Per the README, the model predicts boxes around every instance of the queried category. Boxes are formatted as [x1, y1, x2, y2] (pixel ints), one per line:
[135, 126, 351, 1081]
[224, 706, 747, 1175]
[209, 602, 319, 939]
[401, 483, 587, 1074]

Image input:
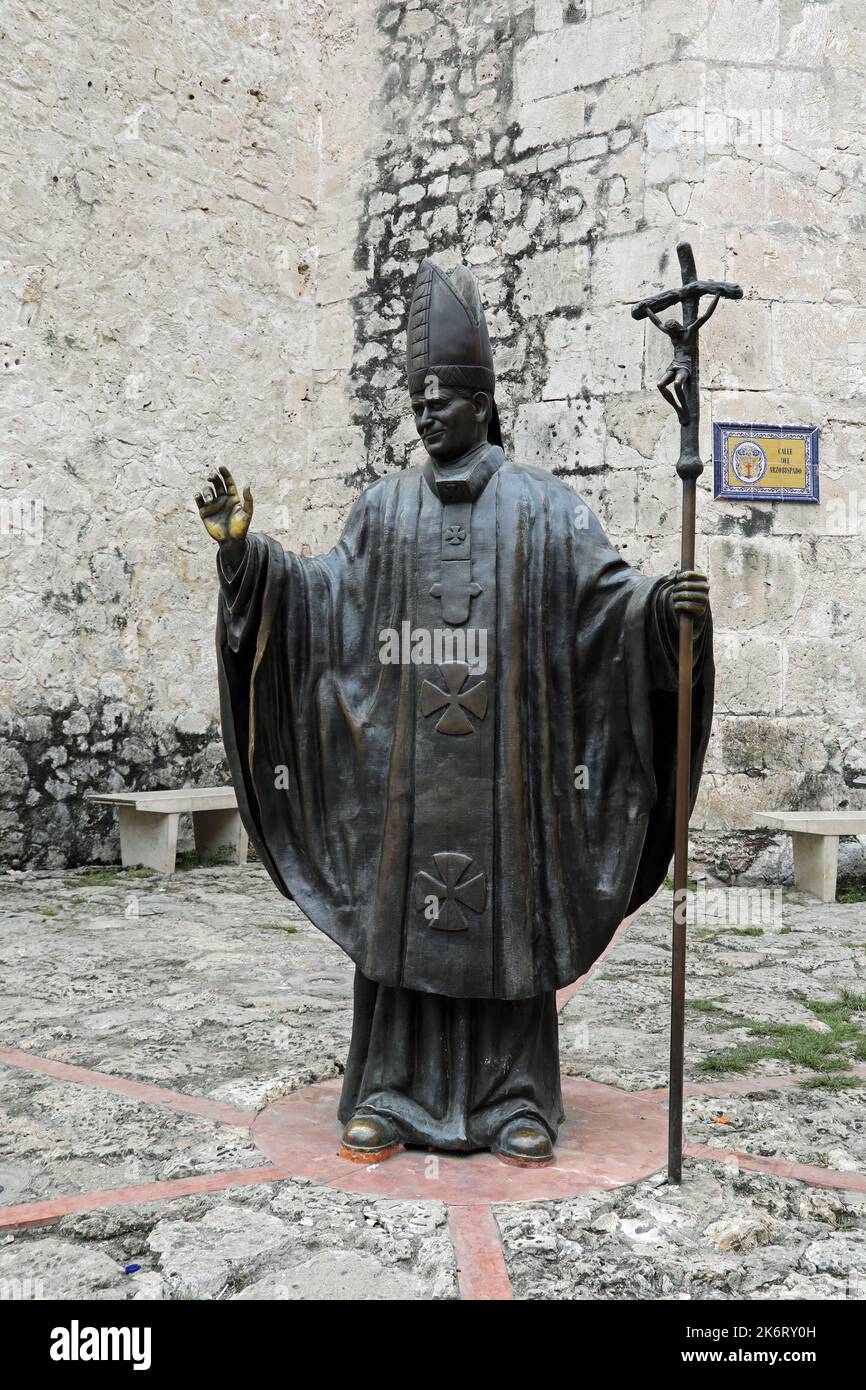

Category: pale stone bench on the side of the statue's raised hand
[85, 787, 249, 873]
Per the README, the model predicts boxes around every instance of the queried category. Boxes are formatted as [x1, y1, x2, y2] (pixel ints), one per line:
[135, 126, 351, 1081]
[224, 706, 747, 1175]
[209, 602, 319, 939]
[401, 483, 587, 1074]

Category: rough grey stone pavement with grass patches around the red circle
[0, 866, 866, 1300]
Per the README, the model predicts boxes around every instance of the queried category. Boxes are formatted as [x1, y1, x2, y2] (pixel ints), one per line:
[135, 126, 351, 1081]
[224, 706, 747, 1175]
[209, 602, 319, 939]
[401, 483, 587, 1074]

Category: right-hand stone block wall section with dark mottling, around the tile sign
[333, 0, 866, 872]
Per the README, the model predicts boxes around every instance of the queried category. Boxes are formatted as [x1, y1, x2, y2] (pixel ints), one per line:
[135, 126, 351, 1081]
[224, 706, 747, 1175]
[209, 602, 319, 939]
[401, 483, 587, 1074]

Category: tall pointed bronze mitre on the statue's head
[406, 259, 496, 396]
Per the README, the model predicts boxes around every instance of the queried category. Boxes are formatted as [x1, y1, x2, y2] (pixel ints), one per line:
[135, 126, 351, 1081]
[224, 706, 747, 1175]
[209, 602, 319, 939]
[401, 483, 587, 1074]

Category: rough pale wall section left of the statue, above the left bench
[0, 0, 378, 863]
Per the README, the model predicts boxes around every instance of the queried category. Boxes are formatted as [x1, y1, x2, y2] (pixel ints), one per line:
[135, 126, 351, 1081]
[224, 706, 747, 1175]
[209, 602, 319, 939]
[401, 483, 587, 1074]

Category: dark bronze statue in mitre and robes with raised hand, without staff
[196, 260, 713, 1165]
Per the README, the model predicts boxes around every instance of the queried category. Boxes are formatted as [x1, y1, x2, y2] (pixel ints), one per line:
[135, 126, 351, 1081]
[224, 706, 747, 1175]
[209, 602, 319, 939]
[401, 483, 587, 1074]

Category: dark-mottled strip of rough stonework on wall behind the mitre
[352, 4, 584, 488]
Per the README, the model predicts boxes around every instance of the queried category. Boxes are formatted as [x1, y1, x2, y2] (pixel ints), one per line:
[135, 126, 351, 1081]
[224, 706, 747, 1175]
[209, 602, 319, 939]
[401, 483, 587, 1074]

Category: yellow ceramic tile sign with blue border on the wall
[713, 421, 819, 502]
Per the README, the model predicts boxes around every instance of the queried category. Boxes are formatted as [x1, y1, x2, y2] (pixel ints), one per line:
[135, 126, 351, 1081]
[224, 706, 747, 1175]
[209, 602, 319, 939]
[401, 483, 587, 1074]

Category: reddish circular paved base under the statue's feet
[253, 1076, 667, 1205]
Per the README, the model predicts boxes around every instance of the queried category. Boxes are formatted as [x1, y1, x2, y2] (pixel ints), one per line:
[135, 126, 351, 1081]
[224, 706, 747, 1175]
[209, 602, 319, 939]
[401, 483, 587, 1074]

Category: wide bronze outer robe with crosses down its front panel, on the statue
[217, 443, 713, 999]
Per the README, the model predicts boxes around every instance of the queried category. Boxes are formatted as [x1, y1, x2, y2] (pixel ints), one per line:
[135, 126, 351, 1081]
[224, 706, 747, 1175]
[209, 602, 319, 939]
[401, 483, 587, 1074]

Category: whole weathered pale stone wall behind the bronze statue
[0, 0, 866, 872]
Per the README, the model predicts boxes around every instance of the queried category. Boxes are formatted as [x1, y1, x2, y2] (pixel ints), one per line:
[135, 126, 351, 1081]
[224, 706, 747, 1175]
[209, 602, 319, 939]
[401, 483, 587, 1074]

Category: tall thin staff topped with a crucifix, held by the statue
[631, 242, 742, 1183]
